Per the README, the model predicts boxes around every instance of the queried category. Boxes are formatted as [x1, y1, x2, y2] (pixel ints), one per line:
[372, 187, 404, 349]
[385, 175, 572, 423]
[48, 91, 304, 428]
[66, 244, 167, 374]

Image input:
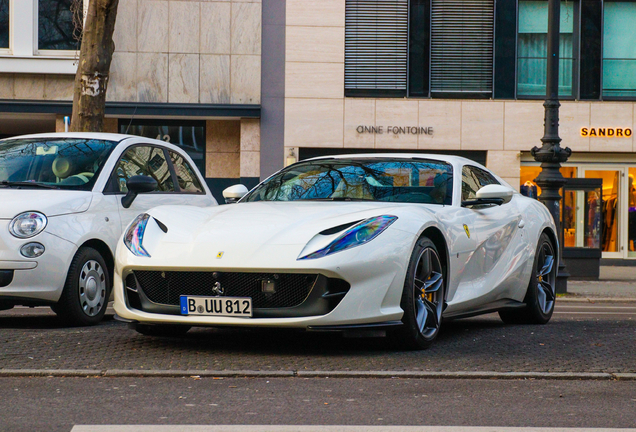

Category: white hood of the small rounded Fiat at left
[0, 188, 93, 219]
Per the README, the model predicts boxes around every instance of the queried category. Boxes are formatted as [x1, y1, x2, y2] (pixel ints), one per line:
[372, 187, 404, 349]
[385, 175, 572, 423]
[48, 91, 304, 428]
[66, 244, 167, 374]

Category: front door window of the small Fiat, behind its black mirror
[114, 146, 175, 192]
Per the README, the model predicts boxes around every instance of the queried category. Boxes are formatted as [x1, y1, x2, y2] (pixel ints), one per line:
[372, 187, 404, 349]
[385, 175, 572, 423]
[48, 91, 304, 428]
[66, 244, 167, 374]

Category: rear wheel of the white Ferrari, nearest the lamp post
[499, 233, 558, 324]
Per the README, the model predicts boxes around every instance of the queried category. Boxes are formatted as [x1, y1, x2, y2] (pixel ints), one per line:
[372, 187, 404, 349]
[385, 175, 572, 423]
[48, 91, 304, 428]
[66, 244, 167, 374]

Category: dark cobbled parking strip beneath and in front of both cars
[0, 302, 636, 373]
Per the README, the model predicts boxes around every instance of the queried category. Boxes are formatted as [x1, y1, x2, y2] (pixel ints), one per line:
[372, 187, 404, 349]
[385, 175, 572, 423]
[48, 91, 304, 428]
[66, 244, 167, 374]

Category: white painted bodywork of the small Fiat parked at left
[0, 133, 217, 305]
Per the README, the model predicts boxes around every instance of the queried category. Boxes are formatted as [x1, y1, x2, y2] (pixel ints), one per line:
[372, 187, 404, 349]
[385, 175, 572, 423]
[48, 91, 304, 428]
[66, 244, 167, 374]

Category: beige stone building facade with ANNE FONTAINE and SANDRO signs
[272, 0, 636, 260]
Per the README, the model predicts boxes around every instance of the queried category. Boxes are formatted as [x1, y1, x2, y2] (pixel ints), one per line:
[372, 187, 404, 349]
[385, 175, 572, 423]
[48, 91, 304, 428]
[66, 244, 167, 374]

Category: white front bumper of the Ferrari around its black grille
[114, 226, 412, 329]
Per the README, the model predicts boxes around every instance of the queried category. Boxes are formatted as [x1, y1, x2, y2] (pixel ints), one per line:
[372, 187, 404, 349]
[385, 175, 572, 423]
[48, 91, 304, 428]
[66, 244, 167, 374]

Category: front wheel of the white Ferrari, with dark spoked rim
[396, 237, 446, 350]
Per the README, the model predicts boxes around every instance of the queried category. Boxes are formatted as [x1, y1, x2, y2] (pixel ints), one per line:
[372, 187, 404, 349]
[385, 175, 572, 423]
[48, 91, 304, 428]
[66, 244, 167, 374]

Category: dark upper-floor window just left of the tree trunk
[38, 0, 83, 51]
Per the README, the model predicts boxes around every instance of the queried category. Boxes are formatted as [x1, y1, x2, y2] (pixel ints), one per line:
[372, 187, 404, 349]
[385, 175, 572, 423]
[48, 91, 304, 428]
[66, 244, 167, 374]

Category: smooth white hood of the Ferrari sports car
[145, 201, 422, 249]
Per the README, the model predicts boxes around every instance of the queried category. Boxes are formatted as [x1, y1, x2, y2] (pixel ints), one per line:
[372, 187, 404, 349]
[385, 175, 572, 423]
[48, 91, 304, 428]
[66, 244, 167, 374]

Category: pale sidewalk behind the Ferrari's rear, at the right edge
[565, 266, 636, 301]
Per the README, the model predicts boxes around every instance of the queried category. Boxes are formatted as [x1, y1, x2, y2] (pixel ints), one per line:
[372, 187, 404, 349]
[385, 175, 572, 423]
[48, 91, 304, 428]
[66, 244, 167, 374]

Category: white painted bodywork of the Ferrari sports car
[114, 154, 558, 340]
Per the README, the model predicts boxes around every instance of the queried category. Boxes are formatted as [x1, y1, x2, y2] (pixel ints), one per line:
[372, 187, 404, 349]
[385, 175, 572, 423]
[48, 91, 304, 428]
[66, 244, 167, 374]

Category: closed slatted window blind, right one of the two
[431, 0, 495, 93]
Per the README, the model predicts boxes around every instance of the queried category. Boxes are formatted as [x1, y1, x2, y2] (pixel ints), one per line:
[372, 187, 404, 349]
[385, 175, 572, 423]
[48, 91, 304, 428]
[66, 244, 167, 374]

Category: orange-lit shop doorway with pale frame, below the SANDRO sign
[584, 166, 626, 258]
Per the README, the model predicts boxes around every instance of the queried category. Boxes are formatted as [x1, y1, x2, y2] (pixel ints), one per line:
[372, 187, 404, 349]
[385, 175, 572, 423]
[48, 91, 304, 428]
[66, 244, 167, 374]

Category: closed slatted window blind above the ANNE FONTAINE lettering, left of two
[345, 0, 409, 91]
